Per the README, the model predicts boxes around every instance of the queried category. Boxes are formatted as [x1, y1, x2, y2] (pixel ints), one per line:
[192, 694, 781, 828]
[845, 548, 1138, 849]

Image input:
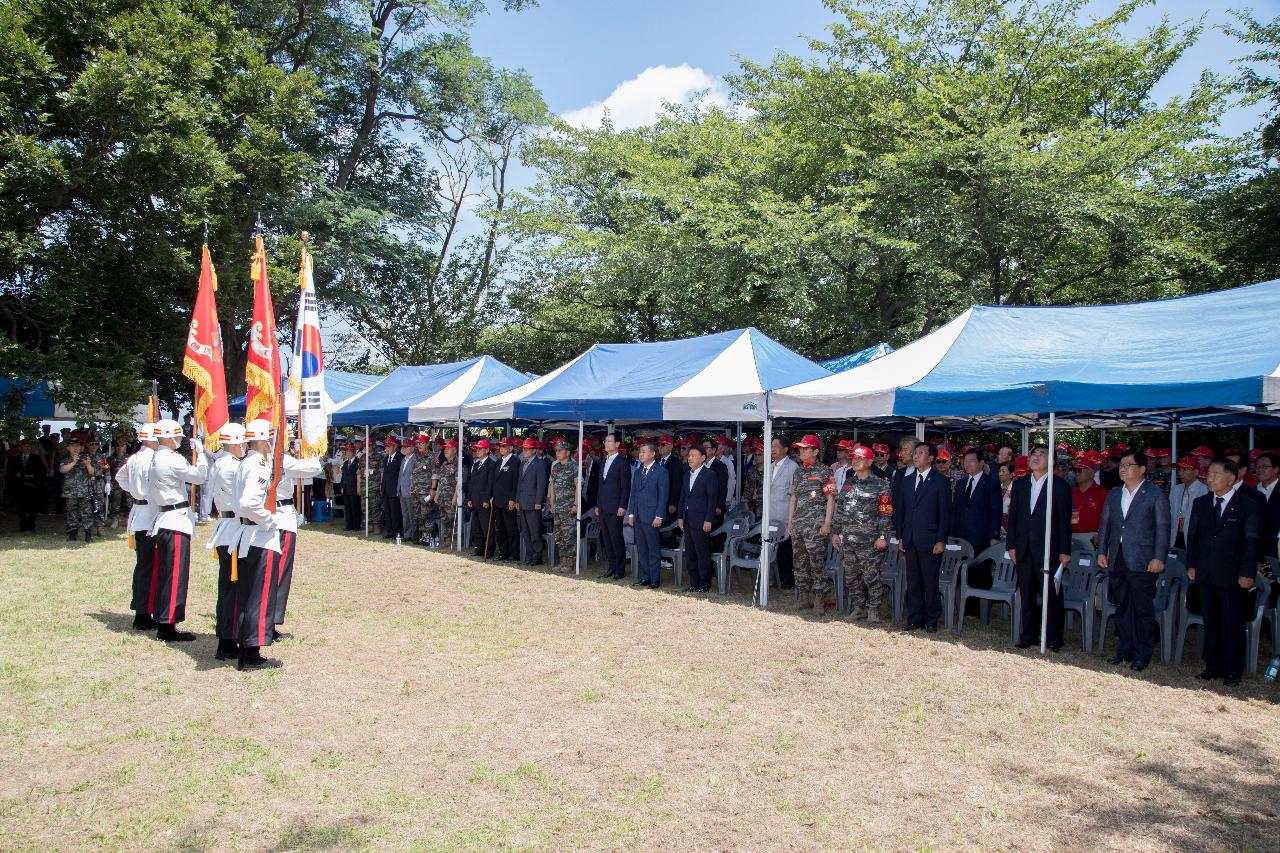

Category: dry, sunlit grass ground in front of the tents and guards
[0, 519, 1280, 850]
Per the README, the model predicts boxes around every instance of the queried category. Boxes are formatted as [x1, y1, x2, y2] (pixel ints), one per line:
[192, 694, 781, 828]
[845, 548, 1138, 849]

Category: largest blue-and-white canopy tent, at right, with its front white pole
[762, 280, 1280, 640]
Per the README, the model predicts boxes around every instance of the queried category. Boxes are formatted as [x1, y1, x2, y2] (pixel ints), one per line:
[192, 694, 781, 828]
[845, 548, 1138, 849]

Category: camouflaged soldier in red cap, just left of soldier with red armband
[787, 435, 836, 616]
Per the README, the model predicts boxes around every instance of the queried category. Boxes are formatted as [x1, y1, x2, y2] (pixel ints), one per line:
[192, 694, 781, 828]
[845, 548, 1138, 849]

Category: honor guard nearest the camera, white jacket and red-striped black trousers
[233, 418, 283, 670]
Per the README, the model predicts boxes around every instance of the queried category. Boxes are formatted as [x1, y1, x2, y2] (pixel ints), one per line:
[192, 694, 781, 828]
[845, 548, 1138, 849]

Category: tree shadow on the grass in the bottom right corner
[1028, 738, 1280, 850]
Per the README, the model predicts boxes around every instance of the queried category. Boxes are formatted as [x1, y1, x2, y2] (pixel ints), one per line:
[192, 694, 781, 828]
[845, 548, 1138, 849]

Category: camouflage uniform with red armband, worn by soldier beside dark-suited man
[831, 471, 893, 619]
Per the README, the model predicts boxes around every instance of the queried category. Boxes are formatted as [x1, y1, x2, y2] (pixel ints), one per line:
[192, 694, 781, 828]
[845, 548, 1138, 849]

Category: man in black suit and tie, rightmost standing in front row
[1187, 459, 1262, 686]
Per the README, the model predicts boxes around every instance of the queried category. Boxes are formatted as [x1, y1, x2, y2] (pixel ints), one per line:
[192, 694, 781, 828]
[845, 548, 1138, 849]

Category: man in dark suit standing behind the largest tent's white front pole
[997, 444, 1070, 652]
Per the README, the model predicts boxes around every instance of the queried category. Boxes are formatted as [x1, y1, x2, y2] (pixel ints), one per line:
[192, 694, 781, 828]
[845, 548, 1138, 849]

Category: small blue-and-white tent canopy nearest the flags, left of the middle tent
[330, 356, 529, 427]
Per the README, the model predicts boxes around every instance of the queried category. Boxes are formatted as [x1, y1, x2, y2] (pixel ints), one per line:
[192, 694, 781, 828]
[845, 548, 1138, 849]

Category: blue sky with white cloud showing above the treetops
[472, 0, 1280, 134]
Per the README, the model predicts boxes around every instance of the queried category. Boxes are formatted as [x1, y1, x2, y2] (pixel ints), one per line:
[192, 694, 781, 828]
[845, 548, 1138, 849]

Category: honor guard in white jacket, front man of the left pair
[147, 419, 209, 643]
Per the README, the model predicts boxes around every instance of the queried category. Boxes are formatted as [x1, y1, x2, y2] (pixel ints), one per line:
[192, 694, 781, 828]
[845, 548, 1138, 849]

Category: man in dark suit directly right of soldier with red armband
[893, 439, 951, 634]
